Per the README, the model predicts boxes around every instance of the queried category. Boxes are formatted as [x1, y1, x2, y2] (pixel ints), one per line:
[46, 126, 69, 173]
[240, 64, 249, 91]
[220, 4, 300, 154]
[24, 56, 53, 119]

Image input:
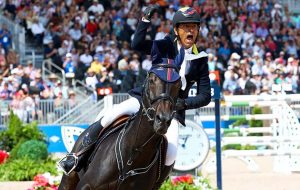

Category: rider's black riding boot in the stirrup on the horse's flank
[58, 119, 103, 175]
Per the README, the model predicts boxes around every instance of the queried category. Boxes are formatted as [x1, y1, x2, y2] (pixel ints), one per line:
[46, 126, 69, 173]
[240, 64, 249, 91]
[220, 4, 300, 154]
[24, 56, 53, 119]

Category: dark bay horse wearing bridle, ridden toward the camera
[59, 64, 181, 190]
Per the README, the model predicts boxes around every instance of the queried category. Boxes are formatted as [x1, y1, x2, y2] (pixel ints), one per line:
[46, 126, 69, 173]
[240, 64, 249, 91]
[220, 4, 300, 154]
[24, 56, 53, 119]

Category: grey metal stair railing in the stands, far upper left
[0, 13, 26, 63]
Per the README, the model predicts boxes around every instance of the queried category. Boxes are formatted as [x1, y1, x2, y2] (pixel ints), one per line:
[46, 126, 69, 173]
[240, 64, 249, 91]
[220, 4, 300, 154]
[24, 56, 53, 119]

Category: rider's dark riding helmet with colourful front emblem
[173, 7, 200, 28]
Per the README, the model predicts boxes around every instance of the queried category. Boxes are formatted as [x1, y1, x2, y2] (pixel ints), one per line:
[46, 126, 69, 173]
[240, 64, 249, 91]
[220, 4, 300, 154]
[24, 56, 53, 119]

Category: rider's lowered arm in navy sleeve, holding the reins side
[185, 58, 211, 109]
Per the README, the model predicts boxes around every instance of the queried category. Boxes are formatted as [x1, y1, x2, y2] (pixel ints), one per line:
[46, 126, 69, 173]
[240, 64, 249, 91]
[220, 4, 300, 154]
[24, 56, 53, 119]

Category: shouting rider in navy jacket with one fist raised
[59, 5, 211, 182]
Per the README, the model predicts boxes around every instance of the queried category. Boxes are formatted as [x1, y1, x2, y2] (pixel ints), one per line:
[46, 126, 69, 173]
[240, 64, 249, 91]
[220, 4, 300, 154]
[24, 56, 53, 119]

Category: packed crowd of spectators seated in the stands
[0, 0, 300, 120]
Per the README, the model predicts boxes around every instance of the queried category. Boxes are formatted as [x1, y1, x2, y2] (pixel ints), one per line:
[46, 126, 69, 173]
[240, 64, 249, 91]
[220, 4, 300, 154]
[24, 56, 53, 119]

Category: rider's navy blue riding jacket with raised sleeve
[129, 21, 211, 125]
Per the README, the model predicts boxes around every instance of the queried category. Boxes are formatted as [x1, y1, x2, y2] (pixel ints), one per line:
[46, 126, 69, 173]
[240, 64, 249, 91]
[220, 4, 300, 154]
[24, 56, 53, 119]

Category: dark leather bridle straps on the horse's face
[142, 64, 179, 121]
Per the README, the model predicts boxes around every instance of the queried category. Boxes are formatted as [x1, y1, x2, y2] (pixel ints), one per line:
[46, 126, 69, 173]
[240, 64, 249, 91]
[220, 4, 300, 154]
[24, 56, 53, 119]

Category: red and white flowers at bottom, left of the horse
[28, 173, 61, 190]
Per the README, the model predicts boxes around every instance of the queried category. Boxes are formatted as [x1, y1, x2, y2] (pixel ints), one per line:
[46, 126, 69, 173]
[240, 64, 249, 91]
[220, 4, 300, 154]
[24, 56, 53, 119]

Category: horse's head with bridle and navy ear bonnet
[143, 64, 181, 135]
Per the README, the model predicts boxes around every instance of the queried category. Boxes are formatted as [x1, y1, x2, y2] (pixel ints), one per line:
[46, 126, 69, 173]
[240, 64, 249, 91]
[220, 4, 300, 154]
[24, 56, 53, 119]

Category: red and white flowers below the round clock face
[160, 174, 213, 190]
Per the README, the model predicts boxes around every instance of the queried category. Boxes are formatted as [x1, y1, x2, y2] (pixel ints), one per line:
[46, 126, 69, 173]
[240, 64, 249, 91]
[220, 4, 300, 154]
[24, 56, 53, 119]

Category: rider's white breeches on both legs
[101, 98, 179, 166]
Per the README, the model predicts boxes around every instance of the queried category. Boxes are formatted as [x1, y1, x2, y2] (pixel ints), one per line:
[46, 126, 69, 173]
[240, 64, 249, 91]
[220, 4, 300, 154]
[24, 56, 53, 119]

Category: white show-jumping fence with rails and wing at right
[207, 101, 300, 173]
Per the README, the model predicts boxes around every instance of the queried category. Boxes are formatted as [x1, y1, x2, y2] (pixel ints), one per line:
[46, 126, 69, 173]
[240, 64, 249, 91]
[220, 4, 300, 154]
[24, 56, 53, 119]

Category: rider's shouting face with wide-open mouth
[174, 23, 199, 49]
